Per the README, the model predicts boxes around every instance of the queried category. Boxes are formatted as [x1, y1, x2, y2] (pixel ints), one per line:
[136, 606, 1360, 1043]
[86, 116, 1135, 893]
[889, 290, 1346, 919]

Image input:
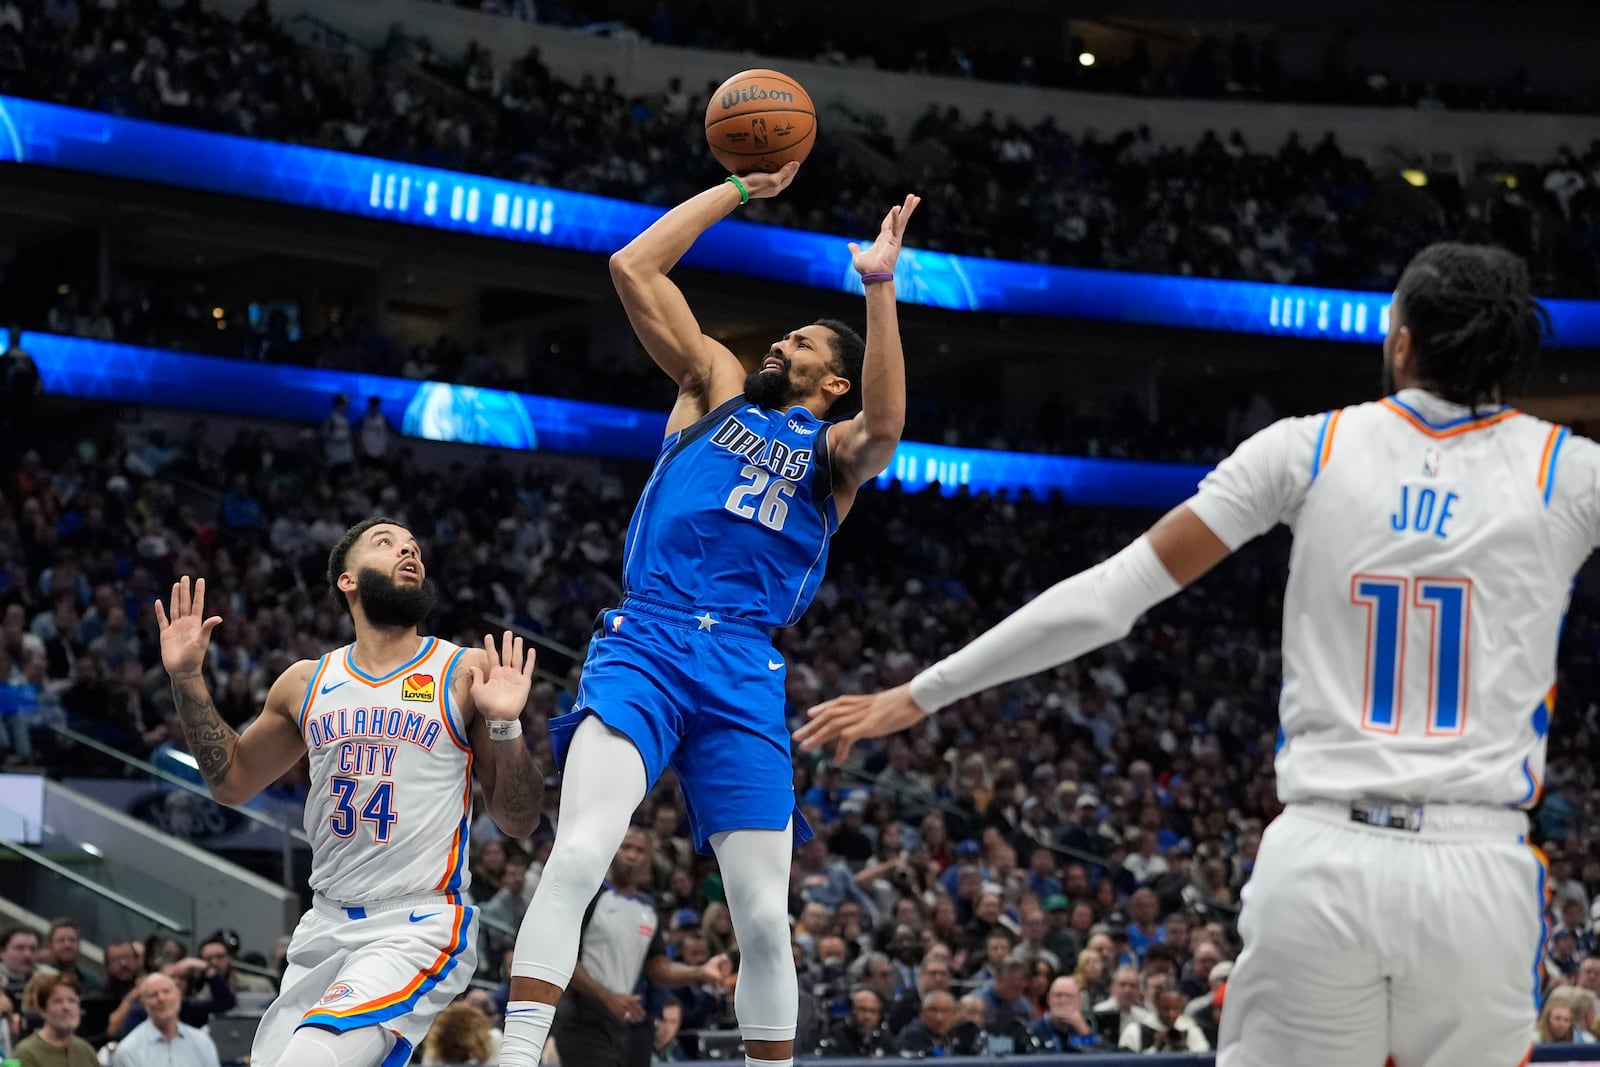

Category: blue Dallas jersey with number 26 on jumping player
[622, 395, 838, 627]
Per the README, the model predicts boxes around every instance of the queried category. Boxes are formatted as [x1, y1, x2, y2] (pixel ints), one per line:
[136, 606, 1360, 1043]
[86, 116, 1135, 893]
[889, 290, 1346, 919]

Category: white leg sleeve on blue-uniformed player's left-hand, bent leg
[510, 715, 645, 989]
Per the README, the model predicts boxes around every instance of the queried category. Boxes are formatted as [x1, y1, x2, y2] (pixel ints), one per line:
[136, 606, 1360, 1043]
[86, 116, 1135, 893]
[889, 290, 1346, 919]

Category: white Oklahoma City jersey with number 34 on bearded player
[299, 637, 472, 905]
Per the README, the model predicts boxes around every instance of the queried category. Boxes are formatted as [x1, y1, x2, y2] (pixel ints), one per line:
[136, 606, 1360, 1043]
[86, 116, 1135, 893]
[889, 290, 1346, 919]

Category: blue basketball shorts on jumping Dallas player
[550, 597, 811, 853]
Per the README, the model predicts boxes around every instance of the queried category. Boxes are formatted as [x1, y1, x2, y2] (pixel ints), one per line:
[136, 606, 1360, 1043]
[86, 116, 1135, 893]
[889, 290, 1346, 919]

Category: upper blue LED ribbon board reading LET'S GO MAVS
[9, 96, 1600, 347]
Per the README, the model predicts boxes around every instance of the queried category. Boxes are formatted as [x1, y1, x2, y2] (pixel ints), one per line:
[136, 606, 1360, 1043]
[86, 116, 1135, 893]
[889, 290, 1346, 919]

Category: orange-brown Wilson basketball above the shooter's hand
[706, 70, 816, 174]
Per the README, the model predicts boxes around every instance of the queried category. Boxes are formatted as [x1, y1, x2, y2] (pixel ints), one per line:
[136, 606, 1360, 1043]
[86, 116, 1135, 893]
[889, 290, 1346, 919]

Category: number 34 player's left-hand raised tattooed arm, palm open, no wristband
[155, 574, 315, 805]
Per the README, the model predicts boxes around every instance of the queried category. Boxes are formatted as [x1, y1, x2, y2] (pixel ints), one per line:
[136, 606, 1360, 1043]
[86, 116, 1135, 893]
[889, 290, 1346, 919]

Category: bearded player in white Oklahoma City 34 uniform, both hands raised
[155, 518, 544, 1067]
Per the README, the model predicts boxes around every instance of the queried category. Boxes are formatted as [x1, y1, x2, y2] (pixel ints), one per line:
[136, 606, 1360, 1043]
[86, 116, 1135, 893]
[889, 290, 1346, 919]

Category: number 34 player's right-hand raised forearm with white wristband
[450, 630, 544, 840]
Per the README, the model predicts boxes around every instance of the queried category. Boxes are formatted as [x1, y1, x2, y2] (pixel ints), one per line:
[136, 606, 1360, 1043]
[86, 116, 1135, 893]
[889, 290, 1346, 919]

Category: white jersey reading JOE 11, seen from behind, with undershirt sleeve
[1190, 389, 1600, 806]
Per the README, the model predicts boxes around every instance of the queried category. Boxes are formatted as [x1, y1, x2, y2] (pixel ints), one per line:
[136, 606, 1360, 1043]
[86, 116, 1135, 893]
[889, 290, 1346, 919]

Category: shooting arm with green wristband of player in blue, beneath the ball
[611, 163, 800, 434]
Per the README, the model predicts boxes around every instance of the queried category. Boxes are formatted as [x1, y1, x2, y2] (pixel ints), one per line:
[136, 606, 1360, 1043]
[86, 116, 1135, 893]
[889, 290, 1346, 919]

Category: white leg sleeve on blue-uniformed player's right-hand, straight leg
[710, 825, 800, 1041]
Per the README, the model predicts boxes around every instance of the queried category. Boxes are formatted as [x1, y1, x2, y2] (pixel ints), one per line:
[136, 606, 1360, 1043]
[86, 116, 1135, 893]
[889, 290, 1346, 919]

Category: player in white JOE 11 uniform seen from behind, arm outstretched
[797, 245, 1561, 1067]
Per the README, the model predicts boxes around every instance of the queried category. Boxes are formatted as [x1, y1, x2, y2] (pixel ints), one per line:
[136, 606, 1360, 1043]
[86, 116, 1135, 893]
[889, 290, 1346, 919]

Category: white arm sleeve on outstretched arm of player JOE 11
[910, 537, 1179, 712]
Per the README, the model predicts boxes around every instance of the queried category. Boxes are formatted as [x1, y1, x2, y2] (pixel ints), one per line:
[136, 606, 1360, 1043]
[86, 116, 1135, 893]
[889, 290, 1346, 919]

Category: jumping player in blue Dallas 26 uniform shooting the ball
[501, 163, 918, 1067]
